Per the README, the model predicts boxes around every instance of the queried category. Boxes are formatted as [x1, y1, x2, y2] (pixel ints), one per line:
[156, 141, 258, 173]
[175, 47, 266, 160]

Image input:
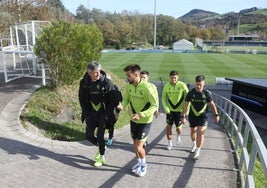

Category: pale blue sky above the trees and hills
[61, 0, 267, 18]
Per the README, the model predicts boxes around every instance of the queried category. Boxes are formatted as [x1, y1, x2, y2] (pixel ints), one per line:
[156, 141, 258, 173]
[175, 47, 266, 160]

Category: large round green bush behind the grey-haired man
[34, 22, 103, 88]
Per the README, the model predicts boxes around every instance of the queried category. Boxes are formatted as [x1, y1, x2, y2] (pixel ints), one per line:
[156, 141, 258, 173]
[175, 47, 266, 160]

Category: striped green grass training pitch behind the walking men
[100, 52, 267, 84]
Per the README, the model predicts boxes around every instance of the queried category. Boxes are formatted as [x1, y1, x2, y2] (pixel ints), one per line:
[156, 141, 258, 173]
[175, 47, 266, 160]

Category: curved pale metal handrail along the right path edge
[213, 93, 267, 188]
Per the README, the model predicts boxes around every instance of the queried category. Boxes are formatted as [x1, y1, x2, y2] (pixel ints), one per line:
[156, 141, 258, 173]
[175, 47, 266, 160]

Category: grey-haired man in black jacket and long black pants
[79, 61, 118, 167]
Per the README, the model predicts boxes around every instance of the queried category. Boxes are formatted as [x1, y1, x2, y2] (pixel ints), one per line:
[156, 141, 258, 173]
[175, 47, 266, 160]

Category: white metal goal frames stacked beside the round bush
[1, 21, 50, 85]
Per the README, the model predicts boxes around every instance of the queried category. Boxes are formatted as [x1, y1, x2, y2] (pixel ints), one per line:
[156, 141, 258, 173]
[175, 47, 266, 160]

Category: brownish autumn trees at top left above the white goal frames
[0, 0, 77, 37]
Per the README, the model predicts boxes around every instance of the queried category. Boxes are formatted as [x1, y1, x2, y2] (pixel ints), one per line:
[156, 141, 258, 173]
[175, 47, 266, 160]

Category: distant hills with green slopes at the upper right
[179, 7, 267, 35]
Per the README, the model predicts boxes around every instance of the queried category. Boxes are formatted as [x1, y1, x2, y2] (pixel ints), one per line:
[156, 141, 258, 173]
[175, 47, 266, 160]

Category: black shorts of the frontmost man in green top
[130, 121, 151, 142]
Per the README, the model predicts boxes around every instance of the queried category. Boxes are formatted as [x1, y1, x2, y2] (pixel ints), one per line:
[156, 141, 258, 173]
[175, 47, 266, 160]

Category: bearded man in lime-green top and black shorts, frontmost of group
[118, 64, 158, 176]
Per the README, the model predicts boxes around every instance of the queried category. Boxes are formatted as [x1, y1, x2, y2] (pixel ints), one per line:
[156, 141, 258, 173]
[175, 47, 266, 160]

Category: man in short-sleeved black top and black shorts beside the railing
[181, 75, 220, 159]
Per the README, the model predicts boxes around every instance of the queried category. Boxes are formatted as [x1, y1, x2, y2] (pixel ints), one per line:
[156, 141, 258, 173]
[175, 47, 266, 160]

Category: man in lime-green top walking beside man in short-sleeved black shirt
[162, 70, 188, 150]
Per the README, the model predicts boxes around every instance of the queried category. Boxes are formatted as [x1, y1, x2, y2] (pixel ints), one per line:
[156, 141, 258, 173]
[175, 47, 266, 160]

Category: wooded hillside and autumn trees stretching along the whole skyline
[0, 0, 267, 49]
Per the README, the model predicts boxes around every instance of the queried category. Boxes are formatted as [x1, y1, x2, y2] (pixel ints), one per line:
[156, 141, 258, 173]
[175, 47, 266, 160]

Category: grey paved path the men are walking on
[0, 78, 239, 188]
